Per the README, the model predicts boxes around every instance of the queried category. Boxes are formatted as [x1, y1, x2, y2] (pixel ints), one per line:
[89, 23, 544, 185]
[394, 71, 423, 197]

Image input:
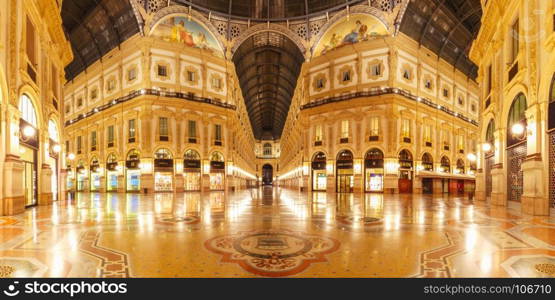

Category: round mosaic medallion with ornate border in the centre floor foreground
[205, 229, 339, 277]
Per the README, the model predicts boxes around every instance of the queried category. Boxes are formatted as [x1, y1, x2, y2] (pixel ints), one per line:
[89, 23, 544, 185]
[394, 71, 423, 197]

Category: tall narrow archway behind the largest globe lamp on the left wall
[19, 94, 40, 206]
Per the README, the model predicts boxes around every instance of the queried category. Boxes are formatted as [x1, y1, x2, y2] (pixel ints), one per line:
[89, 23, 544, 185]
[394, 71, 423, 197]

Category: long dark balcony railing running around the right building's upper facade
[301, 87, 478, 126]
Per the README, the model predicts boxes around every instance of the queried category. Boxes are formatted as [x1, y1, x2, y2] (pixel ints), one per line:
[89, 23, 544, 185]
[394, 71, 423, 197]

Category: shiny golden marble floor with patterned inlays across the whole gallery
[0, 187, 555, 277]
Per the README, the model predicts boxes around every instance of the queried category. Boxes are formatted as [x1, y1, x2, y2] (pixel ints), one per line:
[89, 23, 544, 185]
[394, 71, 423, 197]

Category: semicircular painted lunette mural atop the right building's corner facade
[313, 14, 389, 57]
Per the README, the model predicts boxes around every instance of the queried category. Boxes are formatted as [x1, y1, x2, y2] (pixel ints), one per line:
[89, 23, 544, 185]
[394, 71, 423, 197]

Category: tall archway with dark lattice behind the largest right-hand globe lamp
[506, 93, 527, 202]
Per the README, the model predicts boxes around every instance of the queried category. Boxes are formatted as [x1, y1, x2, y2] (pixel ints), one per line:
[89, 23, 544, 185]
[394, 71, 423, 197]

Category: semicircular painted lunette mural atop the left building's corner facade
[150, 15, 223, 57]
